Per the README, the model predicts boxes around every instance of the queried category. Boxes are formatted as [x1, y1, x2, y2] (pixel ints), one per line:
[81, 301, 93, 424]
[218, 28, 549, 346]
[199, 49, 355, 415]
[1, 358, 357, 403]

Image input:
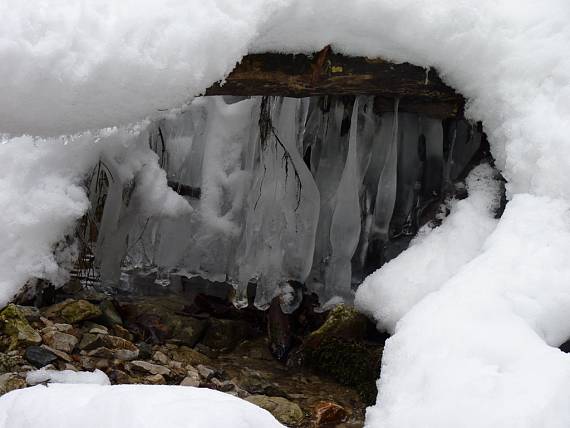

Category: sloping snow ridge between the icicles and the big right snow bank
[355, 164, 500, 332]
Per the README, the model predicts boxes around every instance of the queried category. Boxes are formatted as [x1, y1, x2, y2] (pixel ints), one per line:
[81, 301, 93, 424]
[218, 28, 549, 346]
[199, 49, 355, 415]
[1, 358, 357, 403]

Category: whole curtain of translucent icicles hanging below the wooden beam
[87, 96, 481, 312]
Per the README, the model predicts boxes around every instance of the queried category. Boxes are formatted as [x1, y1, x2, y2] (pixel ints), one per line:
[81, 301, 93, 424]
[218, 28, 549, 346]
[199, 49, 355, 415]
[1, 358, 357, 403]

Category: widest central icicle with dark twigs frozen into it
[236, 97, 319, 312]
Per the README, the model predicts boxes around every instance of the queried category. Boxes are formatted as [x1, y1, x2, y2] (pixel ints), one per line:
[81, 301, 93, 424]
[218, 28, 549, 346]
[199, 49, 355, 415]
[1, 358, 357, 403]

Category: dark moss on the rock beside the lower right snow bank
[304, 337, 382, 404]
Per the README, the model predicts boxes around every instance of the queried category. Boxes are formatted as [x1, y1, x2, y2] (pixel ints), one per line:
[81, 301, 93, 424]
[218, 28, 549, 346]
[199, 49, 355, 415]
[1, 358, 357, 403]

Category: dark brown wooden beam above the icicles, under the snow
[206, 47, 465, 118]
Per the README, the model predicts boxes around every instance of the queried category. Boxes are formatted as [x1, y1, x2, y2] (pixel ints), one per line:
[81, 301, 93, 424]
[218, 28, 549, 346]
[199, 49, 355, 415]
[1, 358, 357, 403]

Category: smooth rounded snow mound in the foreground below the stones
[0, 384, 282, 428]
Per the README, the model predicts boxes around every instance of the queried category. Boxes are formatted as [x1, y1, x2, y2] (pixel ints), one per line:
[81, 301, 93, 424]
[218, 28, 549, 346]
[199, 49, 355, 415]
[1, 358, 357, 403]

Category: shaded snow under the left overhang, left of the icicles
[0, 125, 190, 306]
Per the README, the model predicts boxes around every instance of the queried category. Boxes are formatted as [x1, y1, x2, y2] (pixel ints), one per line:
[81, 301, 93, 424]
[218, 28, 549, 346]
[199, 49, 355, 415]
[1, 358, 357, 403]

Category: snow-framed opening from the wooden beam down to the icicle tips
[65, 47, 492, 313]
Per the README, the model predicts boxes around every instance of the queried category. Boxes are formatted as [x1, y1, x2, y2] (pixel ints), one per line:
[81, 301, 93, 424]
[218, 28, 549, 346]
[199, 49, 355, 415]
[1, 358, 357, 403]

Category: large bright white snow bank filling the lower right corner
[367, 195, 570, 428]
